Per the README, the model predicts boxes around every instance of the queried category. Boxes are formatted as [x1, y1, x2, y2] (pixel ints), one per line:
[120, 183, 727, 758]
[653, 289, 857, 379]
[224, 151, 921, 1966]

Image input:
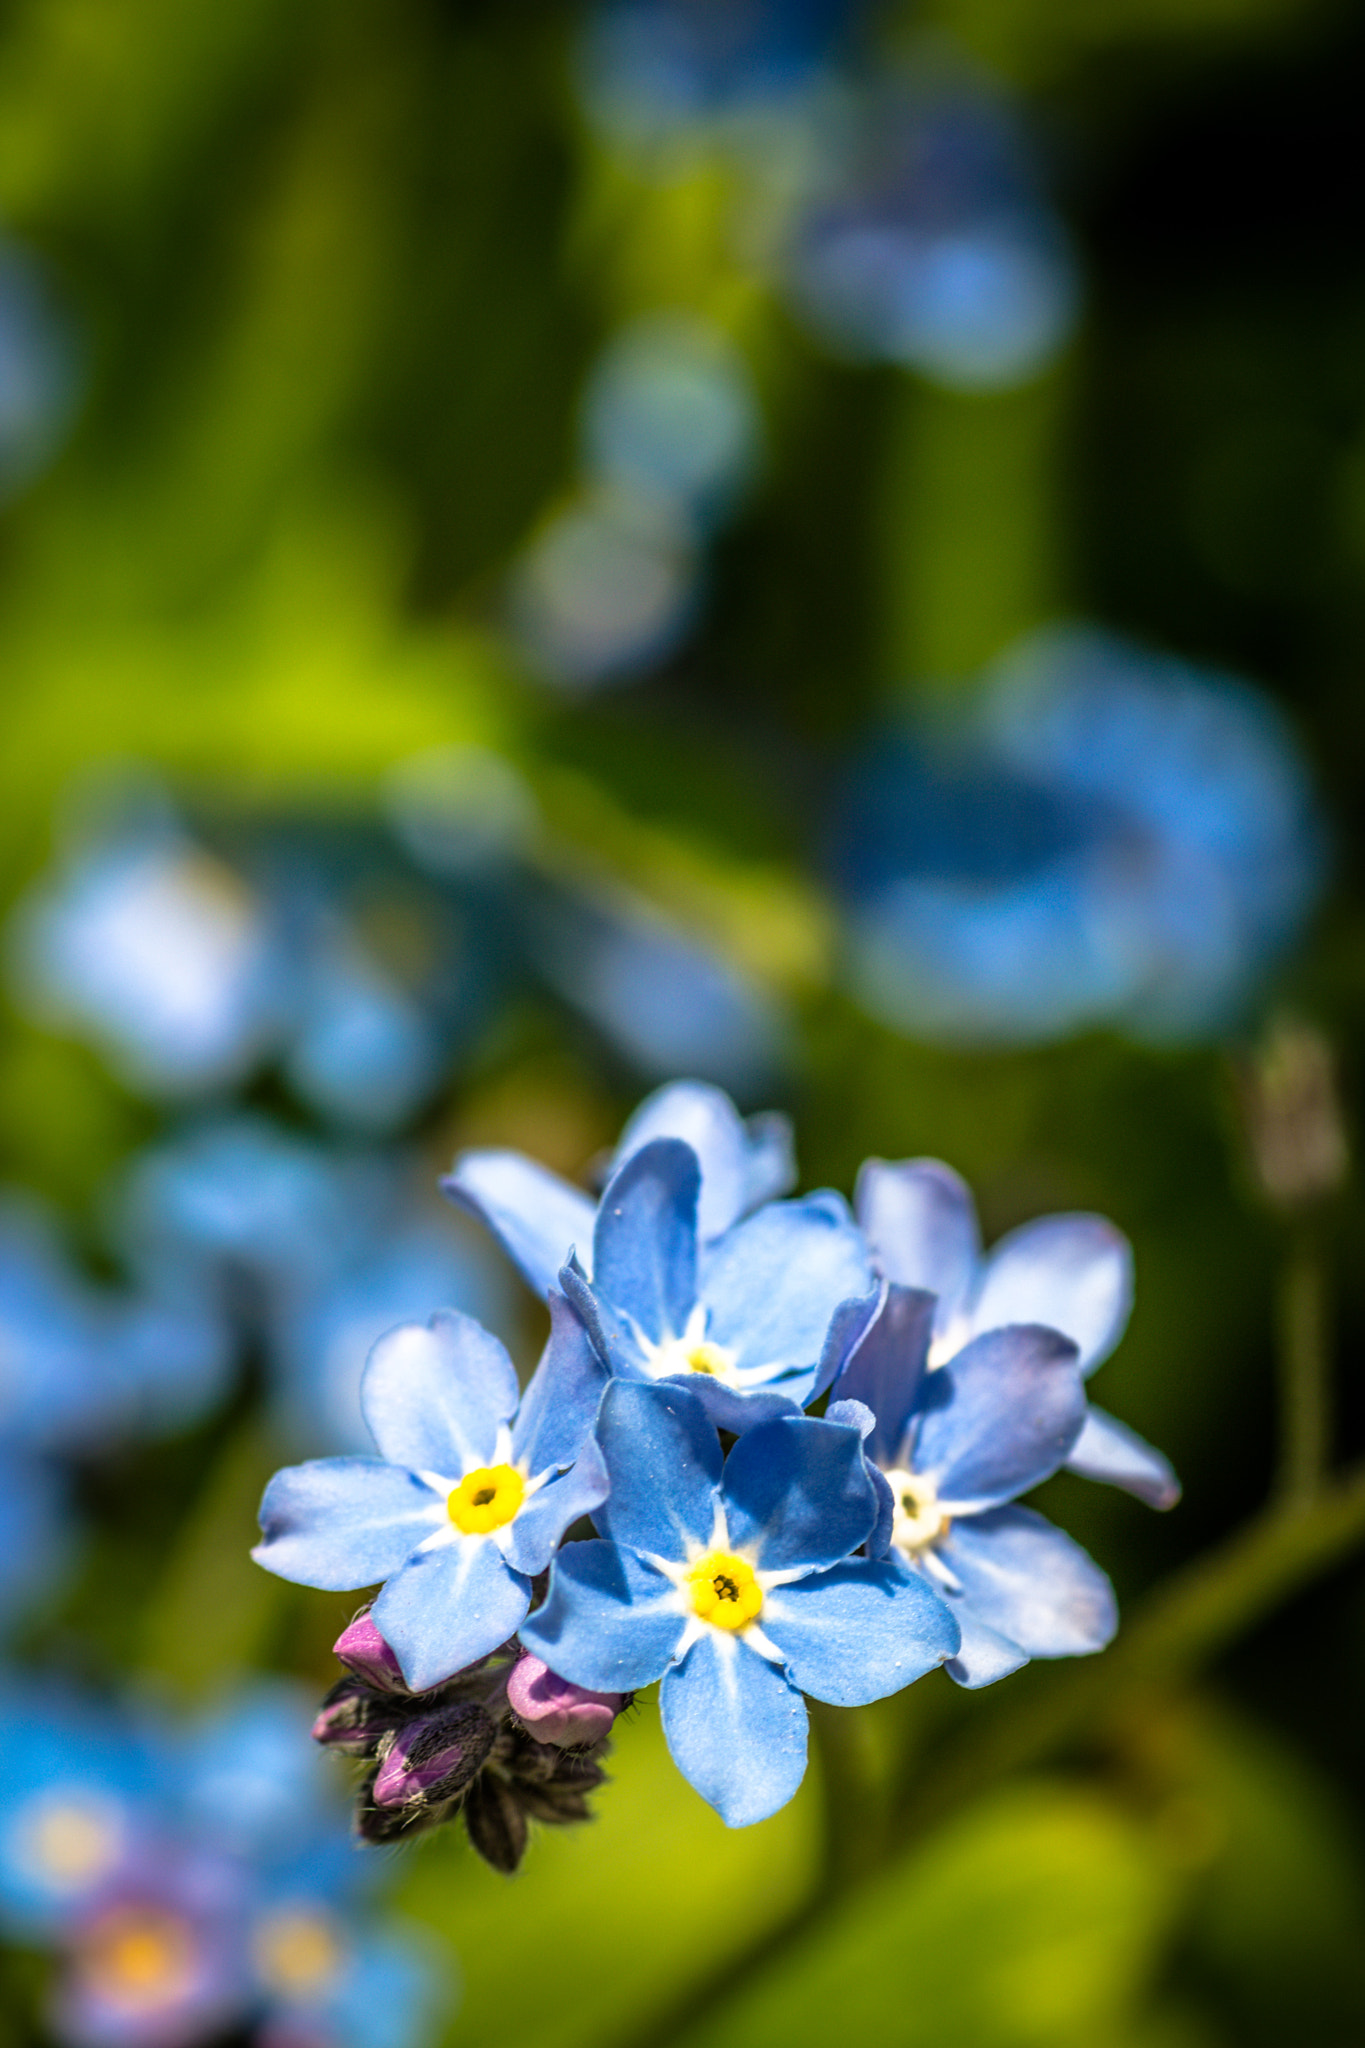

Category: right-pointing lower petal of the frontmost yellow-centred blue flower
[759, 1559, 960, 1706]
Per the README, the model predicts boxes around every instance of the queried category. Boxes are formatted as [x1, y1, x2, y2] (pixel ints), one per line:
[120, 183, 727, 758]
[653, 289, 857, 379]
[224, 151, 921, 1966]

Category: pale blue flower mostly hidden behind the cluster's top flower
[442, 1081, 796, 1294]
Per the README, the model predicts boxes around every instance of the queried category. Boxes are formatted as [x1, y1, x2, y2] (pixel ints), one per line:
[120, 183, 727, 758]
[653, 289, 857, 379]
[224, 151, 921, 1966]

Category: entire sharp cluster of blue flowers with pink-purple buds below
[256, 1083, 1179, 1835]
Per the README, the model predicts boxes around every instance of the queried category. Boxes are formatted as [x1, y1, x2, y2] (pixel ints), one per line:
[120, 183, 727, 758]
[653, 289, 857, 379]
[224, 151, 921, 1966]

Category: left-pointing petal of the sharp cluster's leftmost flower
[252, 1458, 446, 1593]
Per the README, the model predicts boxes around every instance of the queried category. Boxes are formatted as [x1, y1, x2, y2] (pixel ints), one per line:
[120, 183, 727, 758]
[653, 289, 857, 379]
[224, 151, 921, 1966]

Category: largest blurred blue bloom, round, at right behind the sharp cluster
[835, 627, 1324, 1042]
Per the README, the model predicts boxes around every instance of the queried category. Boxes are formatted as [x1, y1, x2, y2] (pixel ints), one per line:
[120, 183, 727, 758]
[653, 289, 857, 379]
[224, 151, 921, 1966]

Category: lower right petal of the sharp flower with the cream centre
[939, 1507, 1117, 1657]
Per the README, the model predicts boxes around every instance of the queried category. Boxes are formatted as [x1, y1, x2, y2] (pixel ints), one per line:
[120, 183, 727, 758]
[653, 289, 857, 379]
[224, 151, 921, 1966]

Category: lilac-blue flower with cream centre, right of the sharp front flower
[829, 1286, 1117, 1688]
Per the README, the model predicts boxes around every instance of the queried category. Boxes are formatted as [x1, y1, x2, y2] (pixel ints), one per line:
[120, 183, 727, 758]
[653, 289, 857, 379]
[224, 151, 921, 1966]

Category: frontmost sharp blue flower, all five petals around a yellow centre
[520, 1380, 958, 1827]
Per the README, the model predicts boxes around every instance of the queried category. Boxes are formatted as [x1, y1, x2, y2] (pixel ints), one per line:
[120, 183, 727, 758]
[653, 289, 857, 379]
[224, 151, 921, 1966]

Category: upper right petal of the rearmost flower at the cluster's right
[970, 1217, 1134, 1374]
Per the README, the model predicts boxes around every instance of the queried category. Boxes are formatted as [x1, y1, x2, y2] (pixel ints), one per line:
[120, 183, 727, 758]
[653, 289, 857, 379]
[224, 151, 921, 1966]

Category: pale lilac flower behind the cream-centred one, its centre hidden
[853, 1159, 1181, 1507]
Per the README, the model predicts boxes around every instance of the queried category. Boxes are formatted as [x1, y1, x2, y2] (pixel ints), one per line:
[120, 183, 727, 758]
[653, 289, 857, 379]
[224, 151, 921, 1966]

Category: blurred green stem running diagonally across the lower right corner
[618, 1464, 1365, 2048]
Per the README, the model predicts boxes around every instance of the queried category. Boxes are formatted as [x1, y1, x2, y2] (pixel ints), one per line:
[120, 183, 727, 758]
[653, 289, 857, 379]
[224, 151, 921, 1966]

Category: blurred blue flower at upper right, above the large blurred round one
[788, 74, 1081, 389]
